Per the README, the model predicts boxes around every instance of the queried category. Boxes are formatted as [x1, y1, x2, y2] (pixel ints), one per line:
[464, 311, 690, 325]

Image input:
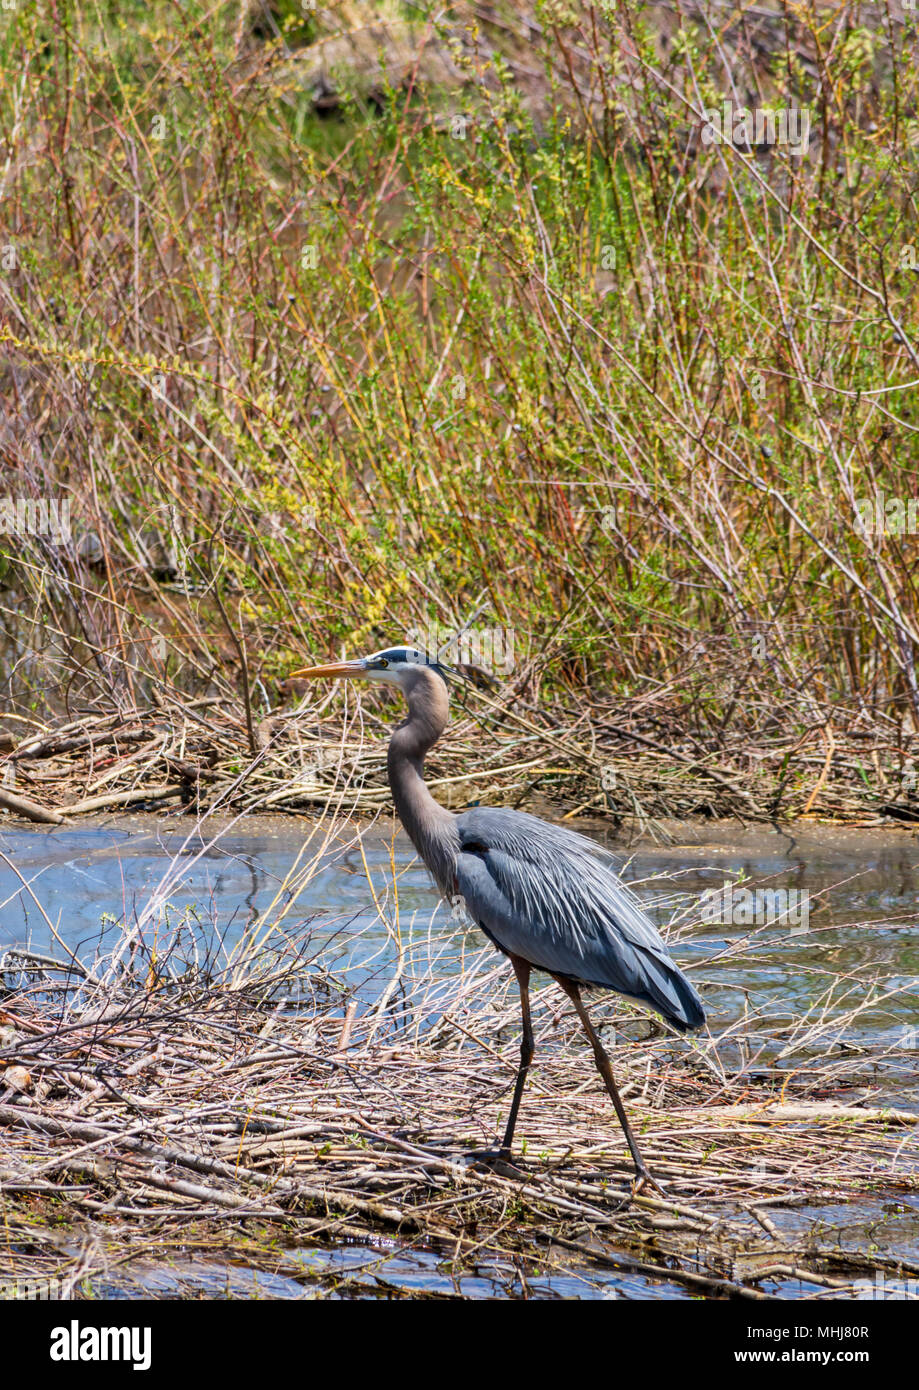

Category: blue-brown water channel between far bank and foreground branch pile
[0, 817, 919, 1049]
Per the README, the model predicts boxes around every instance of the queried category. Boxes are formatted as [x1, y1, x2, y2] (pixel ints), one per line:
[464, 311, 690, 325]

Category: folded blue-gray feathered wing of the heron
[456, 808, 705, 1029]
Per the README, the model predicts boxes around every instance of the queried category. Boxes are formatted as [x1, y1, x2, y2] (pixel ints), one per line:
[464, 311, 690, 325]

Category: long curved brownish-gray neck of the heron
[387, 671, 459, 897]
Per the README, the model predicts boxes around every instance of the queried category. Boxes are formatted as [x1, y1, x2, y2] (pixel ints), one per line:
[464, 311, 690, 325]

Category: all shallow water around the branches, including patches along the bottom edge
[0, 817, 919, 1298]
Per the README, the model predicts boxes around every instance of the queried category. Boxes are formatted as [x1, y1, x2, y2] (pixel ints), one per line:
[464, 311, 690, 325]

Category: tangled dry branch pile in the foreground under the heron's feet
[0, 922, 919, 1298]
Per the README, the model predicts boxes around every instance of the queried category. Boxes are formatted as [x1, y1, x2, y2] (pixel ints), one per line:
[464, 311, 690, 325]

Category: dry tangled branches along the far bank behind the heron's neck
[0, 666, 919, 828]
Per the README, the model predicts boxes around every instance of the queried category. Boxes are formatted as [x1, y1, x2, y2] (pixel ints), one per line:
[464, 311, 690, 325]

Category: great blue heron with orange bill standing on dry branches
[289, 646, 705, 1186]
